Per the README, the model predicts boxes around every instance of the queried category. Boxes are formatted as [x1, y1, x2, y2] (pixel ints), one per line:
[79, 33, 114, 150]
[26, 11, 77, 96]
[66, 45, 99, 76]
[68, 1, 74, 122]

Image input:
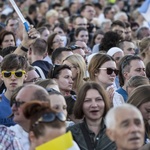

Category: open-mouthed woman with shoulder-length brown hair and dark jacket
[68, 82, 116, 150]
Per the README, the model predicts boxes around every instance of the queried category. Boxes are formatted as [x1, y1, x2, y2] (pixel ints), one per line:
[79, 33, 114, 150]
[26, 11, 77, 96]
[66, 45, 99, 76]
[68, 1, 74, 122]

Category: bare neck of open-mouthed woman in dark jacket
[86, 118, 102, 135]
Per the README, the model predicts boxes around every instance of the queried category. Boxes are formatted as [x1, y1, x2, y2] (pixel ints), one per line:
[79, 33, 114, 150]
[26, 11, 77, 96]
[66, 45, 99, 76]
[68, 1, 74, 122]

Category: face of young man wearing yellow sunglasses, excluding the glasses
[2, 69, 27, 92]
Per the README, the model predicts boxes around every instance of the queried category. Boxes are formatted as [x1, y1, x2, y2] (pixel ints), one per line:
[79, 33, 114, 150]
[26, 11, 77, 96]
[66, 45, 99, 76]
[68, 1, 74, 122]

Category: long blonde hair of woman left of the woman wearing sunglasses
[64, 54, 86, 90]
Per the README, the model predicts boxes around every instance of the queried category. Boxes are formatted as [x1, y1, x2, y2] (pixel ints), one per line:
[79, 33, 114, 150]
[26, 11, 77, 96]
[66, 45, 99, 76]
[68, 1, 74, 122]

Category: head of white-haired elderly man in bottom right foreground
[106, 104, 145, 150]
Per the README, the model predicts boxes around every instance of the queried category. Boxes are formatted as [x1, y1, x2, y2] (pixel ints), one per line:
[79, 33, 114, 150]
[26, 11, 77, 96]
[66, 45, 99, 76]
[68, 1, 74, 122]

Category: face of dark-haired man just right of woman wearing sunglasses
[126, 59, 146, 80]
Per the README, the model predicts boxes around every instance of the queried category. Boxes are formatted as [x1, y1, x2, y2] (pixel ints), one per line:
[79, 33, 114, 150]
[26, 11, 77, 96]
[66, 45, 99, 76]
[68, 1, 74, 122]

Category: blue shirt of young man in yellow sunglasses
[0, 93, 15, 127]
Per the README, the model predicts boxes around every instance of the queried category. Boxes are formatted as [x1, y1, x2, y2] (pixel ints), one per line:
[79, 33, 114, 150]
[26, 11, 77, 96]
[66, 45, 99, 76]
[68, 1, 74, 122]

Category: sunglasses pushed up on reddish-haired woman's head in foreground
[33, 112, 66, 126]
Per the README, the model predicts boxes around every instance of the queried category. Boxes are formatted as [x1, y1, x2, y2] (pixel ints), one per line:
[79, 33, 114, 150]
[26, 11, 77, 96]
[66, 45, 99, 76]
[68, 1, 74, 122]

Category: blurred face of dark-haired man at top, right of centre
[81, 6, 95, 22]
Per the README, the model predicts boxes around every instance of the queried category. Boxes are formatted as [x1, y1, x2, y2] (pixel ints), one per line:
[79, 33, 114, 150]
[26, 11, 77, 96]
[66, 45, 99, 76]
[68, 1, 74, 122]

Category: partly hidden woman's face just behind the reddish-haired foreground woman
[49, 94, 67, 117]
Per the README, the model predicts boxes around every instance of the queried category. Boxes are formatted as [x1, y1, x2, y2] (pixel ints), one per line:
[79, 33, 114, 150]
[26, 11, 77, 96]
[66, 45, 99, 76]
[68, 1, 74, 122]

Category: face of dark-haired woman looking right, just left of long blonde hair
[55, 69, 73, 92]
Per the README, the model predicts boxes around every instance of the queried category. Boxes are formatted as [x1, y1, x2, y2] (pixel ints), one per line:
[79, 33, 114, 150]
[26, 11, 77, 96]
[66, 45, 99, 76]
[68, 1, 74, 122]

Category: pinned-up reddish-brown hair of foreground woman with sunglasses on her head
[23, 100, 66, 138]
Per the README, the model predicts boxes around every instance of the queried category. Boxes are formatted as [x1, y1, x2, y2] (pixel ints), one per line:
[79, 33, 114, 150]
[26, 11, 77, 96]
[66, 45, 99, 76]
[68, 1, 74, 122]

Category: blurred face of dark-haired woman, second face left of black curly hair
[76, 30, 89, 44]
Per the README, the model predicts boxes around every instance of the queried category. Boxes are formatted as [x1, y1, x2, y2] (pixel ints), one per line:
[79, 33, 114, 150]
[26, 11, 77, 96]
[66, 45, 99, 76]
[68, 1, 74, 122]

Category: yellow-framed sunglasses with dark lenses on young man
[2, 70, 26, 78]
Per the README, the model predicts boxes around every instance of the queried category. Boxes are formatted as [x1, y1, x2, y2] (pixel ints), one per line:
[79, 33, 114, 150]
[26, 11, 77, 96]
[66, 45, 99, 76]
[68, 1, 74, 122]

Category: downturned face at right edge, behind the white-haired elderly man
[139, 102, 150, 125]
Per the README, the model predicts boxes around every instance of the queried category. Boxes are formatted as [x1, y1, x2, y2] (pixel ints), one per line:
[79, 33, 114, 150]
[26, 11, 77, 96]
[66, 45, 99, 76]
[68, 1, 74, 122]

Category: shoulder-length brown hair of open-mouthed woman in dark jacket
[74, 82, 110, 119]
